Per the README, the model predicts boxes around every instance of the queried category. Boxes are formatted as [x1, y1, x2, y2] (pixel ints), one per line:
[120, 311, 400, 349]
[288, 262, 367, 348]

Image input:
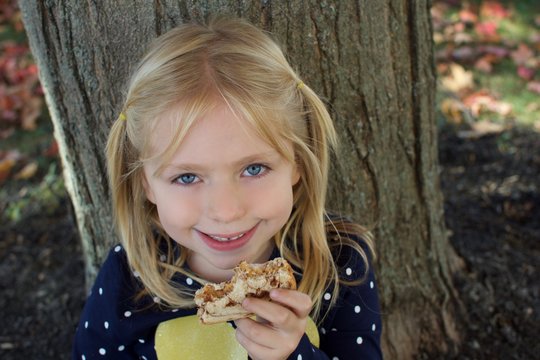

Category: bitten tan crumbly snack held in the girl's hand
[195, 257, 296, 324]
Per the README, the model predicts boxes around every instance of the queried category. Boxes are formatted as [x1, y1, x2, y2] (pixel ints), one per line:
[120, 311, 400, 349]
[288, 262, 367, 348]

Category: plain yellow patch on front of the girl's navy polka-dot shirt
[155, 315, 319, 360]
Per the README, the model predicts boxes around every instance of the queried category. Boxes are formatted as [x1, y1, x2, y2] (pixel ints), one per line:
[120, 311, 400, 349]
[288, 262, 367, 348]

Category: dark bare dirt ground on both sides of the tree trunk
[0, 131, 540, 360]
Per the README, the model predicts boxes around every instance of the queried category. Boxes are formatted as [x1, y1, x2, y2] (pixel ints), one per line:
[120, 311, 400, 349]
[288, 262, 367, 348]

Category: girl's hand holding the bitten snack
[235, 289, 313, 360]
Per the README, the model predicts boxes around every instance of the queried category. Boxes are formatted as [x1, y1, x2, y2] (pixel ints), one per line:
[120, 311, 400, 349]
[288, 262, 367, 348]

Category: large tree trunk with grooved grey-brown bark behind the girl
[19, 0, 460, 359]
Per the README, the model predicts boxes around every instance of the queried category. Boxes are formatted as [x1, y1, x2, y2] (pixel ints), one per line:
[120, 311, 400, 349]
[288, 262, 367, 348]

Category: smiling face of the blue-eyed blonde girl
[144, 105, 300, 281]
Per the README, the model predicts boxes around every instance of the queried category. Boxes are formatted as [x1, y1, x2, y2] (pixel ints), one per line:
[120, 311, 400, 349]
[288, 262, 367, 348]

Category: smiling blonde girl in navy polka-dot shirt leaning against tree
[73, 18, 381, 360]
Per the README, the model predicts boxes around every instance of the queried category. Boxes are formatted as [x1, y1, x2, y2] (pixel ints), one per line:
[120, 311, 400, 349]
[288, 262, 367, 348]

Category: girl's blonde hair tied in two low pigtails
[107, 18, 372, 318]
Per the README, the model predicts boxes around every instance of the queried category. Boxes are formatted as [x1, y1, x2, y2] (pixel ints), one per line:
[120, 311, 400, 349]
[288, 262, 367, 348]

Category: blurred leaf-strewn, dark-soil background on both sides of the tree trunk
[0, 0, 540, 359]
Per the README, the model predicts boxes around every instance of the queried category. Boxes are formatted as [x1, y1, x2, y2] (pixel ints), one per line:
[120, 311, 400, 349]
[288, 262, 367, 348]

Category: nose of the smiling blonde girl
[207, 183, 246, 223]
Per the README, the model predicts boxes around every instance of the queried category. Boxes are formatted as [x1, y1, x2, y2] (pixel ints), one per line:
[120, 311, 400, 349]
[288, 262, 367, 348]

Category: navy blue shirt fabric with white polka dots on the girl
[72, 236, 382, 360]
